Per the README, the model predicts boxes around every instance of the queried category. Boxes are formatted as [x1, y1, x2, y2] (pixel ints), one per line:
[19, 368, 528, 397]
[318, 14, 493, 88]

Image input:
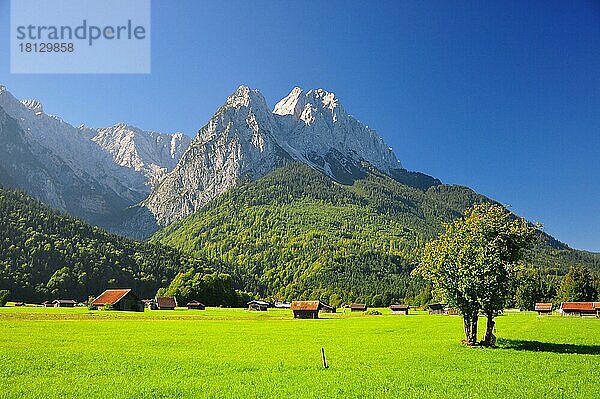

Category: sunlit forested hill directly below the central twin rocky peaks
[152, 164, 600, 305]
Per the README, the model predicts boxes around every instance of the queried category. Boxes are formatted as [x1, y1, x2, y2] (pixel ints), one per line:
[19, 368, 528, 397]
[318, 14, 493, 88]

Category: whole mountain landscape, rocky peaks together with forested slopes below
[0, 86, 600, 305]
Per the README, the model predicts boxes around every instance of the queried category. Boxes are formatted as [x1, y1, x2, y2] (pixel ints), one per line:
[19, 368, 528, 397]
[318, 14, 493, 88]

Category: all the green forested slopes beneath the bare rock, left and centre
[0, 164, 600, 305]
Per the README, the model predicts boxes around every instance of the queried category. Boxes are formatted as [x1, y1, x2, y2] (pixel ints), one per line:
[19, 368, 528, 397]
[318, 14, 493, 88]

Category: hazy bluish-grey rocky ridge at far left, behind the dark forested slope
[0, 86, 190, 225]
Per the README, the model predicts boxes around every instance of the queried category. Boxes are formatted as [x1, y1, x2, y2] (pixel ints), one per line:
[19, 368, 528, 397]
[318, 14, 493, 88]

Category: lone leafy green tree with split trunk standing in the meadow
[415, 203, 536, 345]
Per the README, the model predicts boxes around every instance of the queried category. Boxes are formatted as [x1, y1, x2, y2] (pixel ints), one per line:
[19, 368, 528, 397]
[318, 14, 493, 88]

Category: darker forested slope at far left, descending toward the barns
[0, 189, 222, 301]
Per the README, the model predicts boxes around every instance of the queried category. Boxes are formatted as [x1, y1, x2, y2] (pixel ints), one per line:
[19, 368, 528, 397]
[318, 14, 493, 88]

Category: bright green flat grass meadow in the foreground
[0, 307, 600, 399]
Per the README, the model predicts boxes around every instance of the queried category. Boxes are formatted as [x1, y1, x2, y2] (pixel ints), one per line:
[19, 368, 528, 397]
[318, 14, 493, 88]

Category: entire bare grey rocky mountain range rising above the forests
[0, 82, 426, 238]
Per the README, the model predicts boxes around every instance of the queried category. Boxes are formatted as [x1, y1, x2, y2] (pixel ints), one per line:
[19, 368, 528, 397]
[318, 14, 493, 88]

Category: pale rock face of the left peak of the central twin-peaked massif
[144, 86, 291, 225]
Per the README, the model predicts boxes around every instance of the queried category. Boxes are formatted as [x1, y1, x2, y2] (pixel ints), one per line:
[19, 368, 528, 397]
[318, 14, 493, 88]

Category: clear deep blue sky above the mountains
[0, 0, 600, 251]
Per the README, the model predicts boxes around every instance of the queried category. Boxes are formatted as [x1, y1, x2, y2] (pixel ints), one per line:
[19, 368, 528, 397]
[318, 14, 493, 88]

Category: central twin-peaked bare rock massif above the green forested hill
[143, 86, 408, 226]
